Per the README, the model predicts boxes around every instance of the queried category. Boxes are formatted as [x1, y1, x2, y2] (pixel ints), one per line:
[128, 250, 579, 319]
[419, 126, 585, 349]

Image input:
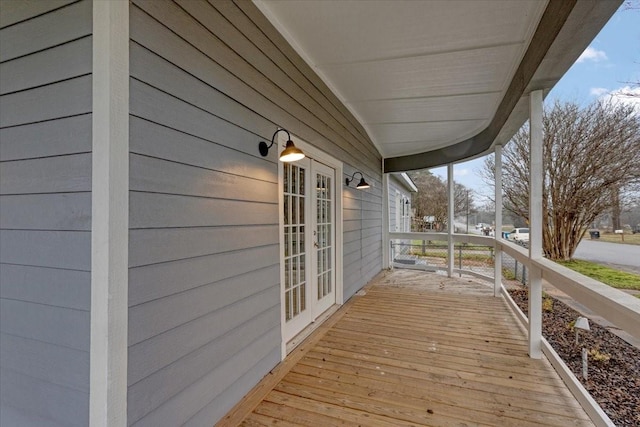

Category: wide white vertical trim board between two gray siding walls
[89, 0, 129, 427]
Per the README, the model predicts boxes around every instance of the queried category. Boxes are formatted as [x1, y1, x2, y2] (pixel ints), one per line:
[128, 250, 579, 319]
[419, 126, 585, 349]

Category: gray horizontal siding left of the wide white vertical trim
[0, 0, 92, 426]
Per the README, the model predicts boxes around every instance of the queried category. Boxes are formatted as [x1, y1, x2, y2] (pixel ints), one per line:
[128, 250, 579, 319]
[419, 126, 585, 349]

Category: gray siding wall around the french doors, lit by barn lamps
[128, 1, 382, 426]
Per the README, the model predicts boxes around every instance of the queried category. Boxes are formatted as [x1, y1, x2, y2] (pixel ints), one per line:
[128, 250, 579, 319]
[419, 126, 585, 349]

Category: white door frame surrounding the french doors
[276, 132, 344, 360]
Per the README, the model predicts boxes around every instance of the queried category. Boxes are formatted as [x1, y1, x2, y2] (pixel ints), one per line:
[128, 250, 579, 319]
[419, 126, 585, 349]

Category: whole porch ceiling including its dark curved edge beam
[254, 0, 619, 172]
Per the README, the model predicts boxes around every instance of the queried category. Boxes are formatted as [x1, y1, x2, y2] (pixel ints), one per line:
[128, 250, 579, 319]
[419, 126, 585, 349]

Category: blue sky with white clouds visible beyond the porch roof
[431, 0, 640, 204]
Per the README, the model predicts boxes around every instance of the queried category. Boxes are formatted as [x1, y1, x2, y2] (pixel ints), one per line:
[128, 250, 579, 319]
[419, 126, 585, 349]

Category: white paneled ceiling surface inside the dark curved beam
[254, 0, 547, 158]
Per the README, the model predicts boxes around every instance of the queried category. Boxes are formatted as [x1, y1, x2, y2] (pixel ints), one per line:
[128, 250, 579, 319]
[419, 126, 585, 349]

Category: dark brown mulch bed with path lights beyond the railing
[509, 289, 640, 427]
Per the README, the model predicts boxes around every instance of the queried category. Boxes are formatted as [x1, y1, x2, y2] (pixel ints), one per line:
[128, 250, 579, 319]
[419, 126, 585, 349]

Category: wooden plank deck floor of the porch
[218, 270, 593, 427]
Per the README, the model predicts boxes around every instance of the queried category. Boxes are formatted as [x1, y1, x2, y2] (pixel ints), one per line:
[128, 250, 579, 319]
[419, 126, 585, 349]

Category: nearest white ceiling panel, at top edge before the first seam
[256, 0, 546, 66]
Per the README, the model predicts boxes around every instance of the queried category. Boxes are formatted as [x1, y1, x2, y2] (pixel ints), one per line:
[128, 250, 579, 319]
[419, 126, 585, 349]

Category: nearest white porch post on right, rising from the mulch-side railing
[529, 90, 544, 359]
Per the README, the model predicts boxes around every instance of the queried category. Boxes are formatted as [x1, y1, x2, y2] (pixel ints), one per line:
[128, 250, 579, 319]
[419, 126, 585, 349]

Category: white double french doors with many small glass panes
[281, 158, 336, 342]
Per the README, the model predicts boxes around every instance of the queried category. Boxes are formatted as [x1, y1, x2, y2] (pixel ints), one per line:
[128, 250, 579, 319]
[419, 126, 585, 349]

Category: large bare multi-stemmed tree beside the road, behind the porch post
[482, 101, 640, 260]
